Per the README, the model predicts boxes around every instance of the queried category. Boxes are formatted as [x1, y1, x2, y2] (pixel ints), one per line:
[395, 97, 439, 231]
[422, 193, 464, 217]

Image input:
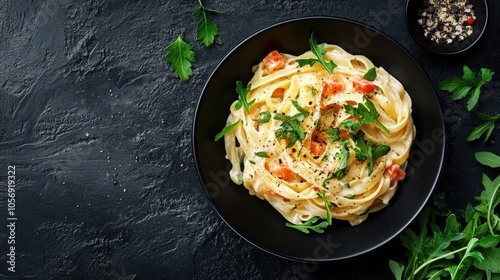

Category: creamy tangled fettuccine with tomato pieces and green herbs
[224, 40, 416, 231]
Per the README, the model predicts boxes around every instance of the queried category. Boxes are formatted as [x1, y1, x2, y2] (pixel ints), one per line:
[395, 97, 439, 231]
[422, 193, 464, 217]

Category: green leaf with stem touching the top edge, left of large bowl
[191, 0, 222, 47]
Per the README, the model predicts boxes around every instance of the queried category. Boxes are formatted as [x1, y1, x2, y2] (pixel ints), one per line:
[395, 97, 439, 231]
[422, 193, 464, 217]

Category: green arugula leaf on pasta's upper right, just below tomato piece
[341, 95, 390, 133]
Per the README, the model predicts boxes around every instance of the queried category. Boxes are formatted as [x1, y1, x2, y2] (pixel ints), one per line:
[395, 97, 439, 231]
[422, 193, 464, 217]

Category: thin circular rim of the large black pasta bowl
[191, 15, 447, 263]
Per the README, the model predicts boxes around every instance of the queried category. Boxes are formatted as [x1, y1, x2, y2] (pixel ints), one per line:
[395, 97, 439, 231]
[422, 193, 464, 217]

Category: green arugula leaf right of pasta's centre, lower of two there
[351, 131, 391, 175]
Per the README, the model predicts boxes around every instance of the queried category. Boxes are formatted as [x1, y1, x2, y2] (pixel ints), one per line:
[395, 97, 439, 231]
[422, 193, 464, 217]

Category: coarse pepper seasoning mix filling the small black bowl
[418, 0, 476, 44]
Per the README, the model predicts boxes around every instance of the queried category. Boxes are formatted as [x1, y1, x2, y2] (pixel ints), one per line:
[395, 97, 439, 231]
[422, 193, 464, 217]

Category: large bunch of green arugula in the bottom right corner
[389, 152, 500, 280]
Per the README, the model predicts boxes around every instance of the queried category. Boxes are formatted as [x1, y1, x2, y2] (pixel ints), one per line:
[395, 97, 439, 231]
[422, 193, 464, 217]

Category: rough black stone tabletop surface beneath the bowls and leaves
[0, 0, 500, 279]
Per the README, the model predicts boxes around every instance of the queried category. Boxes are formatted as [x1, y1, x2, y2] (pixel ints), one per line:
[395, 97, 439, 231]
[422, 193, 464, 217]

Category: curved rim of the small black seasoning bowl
[405, 0, 489, 56]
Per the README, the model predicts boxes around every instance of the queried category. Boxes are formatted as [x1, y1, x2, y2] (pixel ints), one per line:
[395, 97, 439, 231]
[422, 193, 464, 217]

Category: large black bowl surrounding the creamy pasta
[193, 17, 445, 262]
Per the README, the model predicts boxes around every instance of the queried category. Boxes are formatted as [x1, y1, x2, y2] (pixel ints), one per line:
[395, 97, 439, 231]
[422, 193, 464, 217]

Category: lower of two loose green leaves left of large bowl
[165, 35, 196, 82]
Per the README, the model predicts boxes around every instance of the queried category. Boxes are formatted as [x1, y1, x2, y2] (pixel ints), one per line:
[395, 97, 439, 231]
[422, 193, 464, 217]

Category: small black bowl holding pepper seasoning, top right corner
[406, 0, 488, 55]
